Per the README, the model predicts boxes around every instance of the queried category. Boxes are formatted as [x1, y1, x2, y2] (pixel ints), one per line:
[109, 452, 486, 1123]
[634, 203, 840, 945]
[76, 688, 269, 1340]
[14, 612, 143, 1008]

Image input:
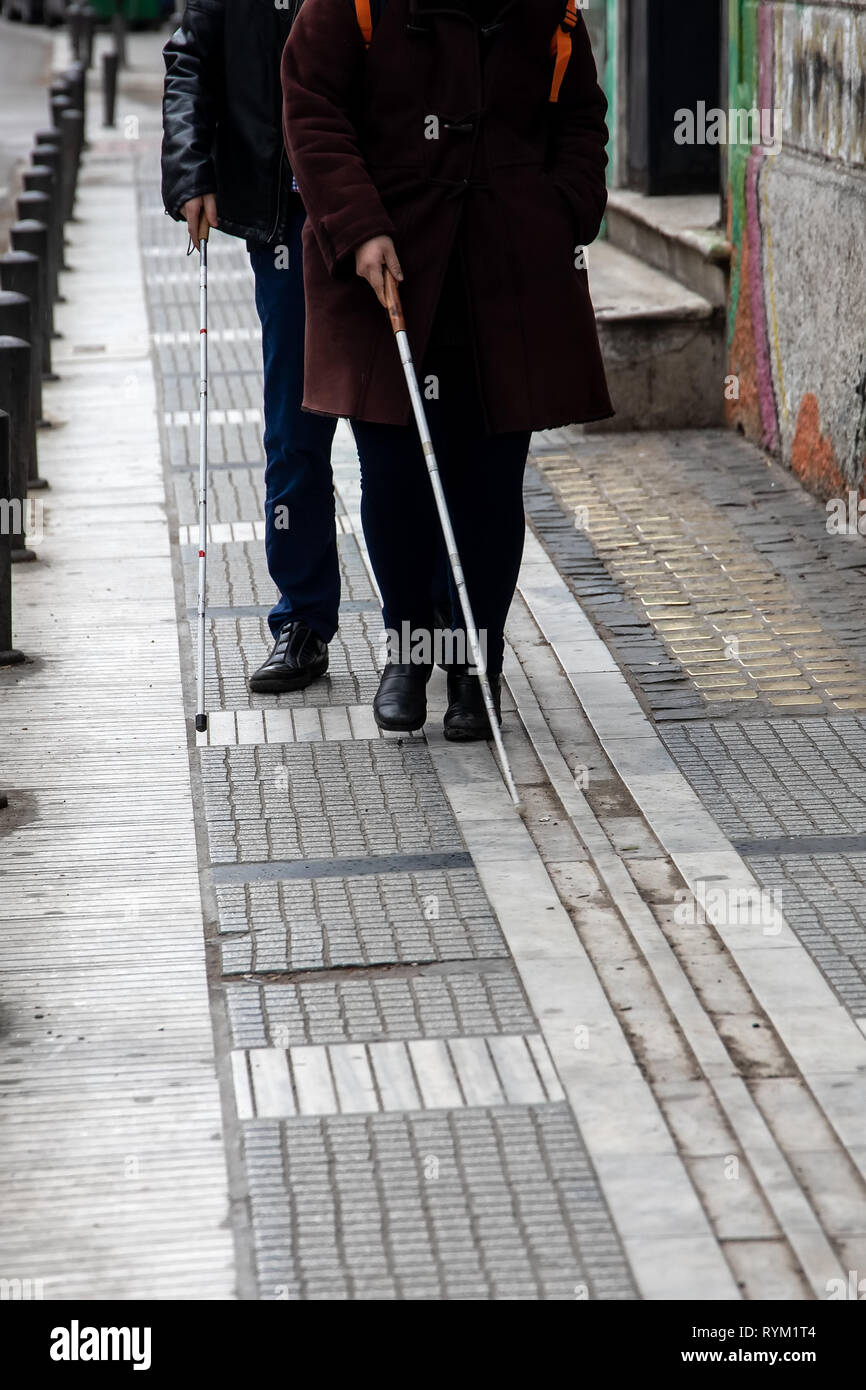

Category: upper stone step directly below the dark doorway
[606, 188, 731, 309]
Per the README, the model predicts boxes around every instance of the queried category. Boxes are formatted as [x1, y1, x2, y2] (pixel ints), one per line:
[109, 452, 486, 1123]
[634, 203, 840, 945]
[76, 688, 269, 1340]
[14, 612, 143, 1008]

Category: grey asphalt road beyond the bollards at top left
[0, 19, 53, 252]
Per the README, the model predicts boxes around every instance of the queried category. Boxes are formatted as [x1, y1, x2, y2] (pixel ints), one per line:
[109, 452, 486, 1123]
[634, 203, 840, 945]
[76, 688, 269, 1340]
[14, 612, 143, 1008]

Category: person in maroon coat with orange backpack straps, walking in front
[282, 0, 613, 741]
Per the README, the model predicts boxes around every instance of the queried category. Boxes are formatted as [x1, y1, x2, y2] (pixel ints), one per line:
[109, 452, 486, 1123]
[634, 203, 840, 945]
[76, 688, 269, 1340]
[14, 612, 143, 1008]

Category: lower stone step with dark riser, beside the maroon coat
[585, 242, 724, 431]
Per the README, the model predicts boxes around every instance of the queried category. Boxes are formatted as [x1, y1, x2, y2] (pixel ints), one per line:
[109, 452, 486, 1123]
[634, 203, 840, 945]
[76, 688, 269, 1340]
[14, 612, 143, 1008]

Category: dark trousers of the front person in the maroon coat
[352, 352, 530, 674]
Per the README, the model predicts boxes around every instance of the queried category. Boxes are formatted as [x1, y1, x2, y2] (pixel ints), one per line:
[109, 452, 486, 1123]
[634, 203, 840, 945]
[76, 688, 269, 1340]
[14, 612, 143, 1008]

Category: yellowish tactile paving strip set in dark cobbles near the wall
[535, 441, 866, 713]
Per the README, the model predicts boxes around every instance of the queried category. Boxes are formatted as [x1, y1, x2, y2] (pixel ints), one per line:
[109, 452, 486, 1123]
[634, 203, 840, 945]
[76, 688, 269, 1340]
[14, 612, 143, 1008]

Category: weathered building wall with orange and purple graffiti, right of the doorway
[728, 0, 866, 496]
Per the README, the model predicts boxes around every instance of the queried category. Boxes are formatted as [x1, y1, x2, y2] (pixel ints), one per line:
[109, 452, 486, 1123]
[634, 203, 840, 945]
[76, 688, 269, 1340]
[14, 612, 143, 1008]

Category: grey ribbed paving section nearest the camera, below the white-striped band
[245, 1105, 635, 1301]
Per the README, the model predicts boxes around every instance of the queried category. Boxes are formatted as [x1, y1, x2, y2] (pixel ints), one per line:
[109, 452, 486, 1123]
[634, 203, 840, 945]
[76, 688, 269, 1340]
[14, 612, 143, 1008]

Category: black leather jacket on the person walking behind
[163, 0, 302, 242]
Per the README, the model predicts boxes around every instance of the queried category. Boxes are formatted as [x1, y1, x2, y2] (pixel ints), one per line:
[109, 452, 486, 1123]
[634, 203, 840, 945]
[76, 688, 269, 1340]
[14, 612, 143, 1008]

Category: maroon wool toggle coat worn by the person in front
[282, 0, 613, 434]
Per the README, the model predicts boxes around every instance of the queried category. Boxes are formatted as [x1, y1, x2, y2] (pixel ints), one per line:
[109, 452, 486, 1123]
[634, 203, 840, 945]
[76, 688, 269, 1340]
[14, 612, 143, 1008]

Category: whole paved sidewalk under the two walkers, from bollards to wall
[0, 67, 866, 1300]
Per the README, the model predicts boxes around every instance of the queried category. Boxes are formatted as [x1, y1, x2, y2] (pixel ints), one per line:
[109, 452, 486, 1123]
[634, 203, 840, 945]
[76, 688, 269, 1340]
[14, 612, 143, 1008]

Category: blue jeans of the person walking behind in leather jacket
[249, 209, 339, 642]
